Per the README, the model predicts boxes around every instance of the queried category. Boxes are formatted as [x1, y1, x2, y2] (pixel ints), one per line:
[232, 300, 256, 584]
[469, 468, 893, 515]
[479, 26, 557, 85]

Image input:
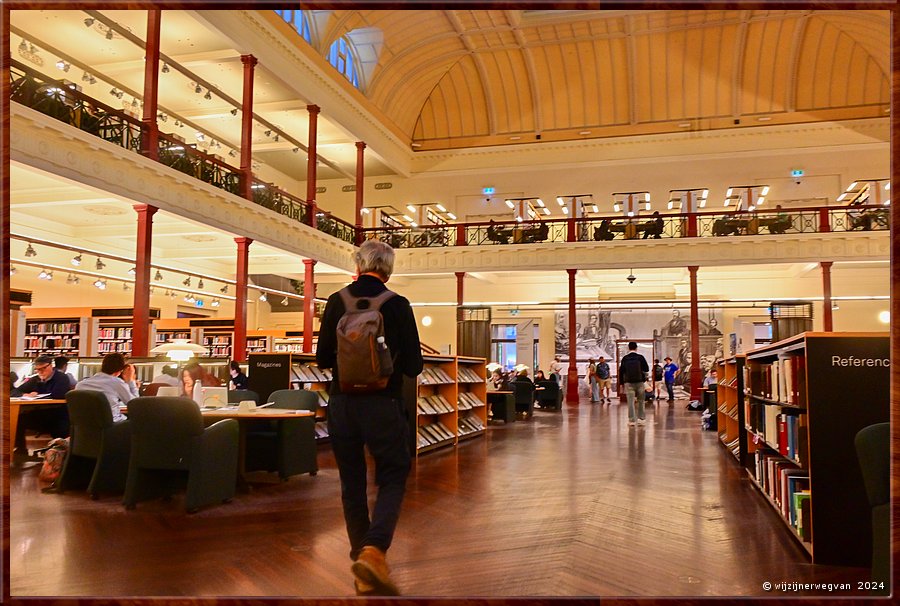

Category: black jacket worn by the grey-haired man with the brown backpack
[316, 276, 422, 400]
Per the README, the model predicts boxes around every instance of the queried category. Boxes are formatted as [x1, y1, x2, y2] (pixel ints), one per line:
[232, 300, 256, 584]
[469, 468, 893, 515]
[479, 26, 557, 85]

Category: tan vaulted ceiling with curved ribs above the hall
[314, 10, 890, 150]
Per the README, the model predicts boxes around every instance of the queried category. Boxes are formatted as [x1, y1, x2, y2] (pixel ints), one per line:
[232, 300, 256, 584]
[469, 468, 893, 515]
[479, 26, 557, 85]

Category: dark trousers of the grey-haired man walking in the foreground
[328, 394, 411, 560]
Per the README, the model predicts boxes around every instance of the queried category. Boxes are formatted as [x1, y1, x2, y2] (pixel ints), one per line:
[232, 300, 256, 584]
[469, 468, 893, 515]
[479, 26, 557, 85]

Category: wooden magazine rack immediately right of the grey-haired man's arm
[415, 356, 459, 455]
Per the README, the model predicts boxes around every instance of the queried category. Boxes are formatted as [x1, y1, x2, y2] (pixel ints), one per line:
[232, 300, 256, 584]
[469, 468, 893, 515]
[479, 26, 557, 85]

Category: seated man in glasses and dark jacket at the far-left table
[14, 356, 72, 456]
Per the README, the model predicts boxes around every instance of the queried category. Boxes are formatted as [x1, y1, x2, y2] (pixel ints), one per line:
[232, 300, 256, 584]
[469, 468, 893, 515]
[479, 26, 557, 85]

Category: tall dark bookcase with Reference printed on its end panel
[743, 332, 890, 566]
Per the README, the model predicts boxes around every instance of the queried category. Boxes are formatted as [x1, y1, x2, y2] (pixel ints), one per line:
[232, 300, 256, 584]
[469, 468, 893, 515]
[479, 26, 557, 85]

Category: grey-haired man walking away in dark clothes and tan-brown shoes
[316, 240, 422, 596]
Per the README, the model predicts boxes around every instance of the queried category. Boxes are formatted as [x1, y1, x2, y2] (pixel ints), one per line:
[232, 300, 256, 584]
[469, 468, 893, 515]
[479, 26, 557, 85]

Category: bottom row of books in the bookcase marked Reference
[755, 450, 812, 542]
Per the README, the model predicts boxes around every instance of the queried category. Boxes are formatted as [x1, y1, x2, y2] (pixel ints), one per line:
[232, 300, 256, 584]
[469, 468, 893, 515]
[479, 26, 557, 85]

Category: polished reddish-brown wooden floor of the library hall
[9, 401, 866, 598]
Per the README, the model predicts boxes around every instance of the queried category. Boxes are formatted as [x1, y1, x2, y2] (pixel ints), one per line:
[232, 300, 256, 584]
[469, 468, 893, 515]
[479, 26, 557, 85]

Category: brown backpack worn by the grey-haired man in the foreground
[337, 287, 396, 393]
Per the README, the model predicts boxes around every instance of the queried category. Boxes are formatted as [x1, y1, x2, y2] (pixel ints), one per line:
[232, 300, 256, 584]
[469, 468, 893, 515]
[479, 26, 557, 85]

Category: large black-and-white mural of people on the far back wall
[554, 308, 724, 384]
